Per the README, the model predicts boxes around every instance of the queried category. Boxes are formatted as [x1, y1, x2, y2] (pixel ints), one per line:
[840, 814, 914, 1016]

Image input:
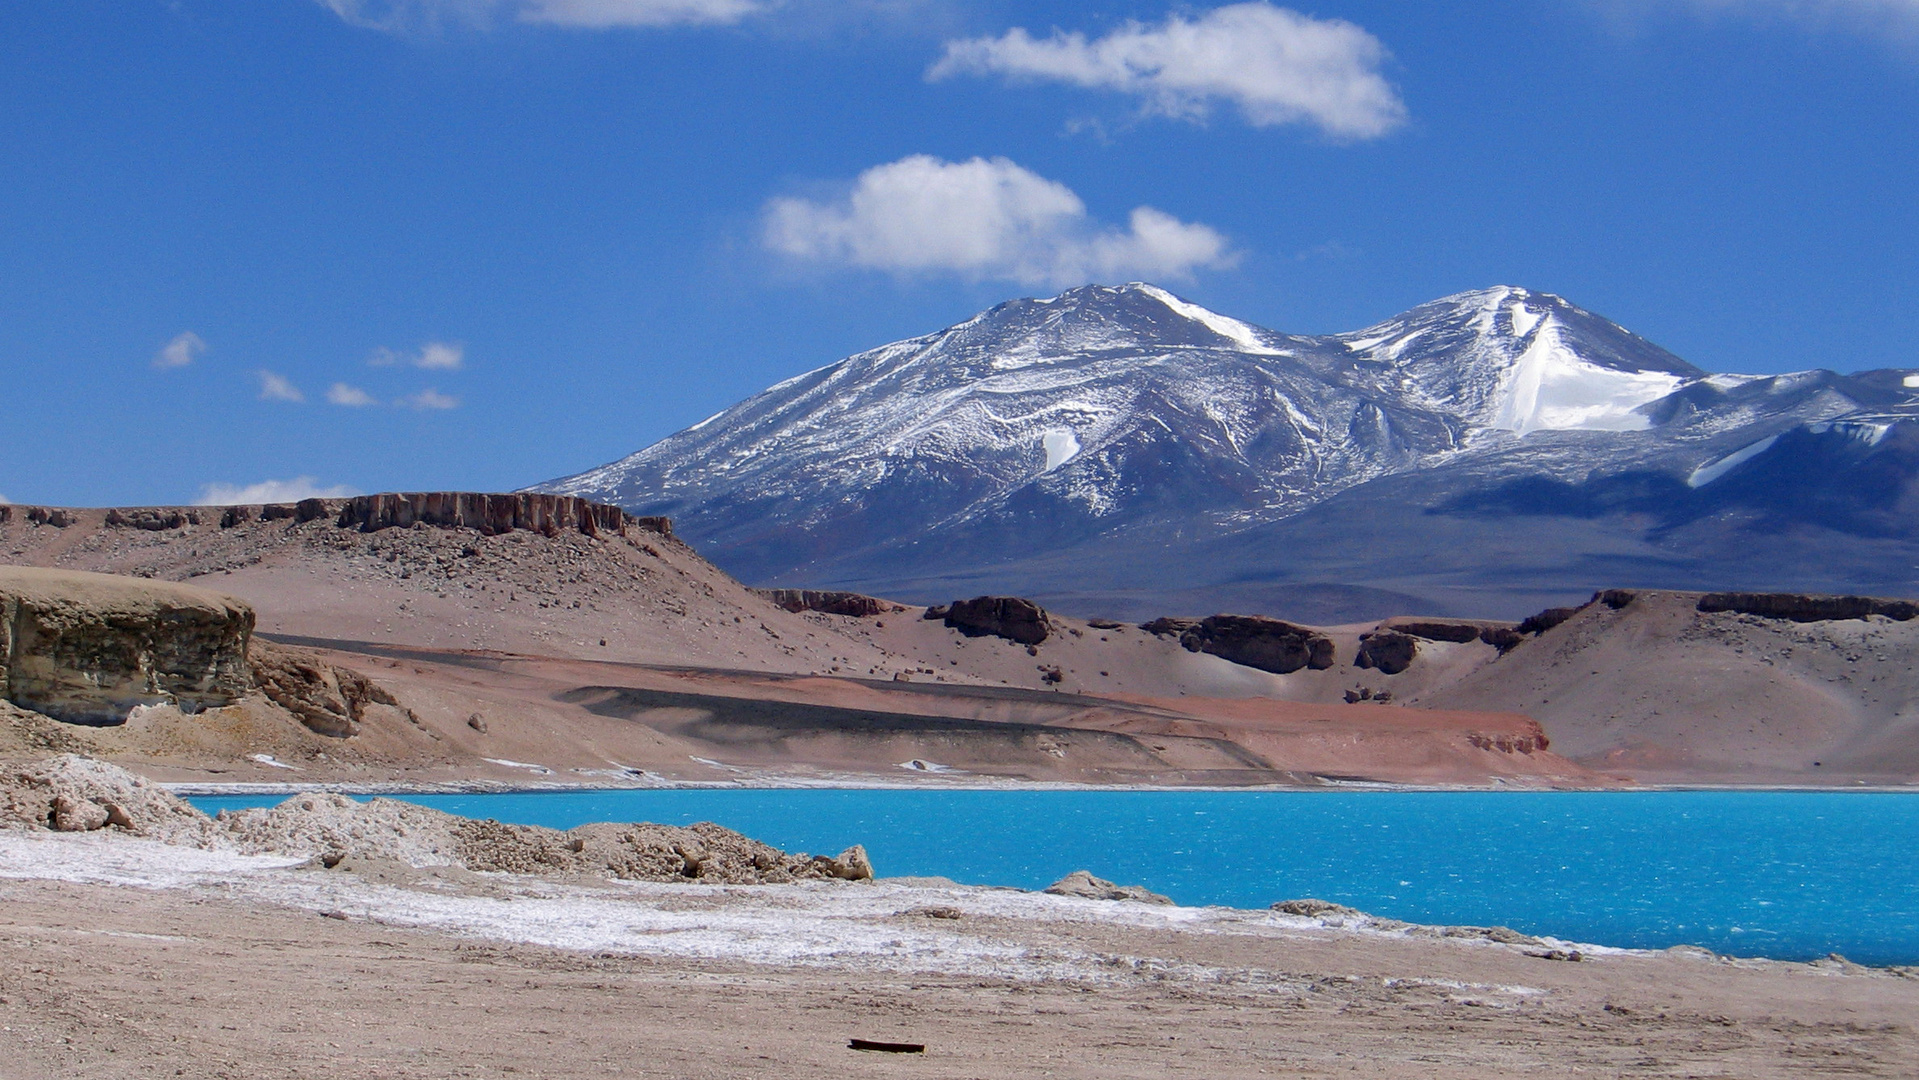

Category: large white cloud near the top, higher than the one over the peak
[927, 2, 1407, 138]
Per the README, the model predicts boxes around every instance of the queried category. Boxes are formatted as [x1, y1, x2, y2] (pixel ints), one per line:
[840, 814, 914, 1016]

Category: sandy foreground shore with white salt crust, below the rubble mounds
[0, 831, 1919, 1080]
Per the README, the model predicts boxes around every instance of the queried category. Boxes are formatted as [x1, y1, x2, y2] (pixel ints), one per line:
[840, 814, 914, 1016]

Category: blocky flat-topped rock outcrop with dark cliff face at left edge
[0, 566, 253, 725]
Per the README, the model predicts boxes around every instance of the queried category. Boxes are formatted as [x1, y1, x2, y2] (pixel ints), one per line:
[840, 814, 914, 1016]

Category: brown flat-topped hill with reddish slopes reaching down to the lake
[0, 493, 1595, 785]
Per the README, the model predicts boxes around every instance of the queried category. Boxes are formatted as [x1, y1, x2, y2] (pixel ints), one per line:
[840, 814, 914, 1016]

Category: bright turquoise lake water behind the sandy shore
[192, 788, 1919, 965]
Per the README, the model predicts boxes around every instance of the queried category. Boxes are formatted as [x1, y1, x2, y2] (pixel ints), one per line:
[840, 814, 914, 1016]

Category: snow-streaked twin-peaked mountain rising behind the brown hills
[539, 284, 1919, 621]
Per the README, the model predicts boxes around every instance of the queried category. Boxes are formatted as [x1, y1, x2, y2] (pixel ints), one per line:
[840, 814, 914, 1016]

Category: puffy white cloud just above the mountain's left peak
[764, 153, 1238, 286]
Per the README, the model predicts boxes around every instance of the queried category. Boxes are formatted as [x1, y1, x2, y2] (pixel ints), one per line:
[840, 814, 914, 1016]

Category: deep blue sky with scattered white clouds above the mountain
[0, 0, 1919, 505]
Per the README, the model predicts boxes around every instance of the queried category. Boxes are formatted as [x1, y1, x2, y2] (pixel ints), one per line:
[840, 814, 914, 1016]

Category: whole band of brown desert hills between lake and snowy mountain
[0, 495, 1919, 787]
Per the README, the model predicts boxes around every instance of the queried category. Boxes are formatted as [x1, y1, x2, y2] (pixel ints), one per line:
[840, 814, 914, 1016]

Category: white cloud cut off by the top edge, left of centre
[319, 0, 771, 33]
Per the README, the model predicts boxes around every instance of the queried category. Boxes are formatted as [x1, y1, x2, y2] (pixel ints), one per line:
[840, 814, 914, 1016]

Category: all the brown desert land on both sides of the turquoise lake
[0, 497, 1919, 1078]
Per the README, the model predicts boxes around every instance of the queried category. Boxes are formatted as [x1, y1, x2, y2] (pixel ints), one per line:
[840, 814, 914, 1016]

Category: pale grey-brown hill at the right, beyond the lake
[1409, 589, 1919, 785]
